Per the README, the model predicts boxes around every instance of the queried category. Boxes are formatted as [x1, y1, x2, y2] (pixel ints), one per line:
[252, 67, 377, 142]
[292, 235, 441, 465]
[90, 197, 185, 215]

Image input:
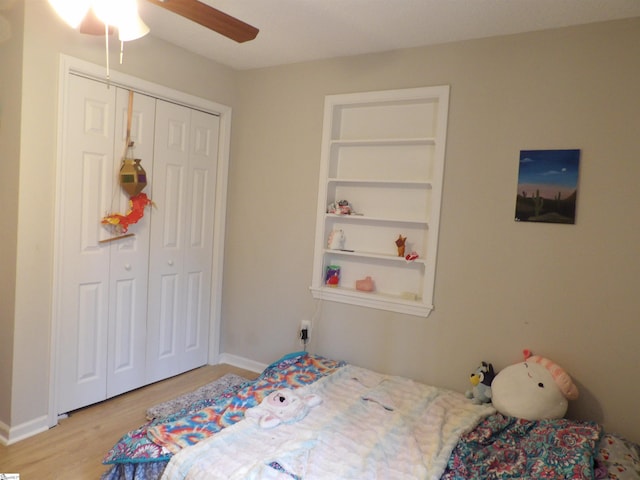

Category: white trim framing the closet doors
[48, 55, 231, 427]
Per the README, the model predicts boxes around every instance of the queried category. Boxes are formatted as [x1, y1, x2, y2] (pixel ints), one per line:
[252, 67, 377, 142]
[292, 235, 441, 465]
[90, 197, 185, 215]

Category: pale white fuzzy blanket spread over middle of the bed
[162, 365, 494, 480]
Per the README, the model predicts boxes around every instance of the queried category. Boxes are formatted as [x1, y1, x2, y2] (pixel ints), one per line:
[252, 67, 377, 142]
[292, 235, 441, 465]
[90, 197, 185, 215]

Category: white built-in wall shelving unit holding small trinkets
[311, 86, 449, 317]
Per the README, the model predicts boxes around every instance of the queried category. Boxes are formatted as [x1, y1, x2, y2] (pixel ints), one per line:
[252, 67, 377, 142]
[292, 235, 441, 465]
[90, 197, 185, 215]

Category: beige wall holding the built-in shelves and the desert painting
[221, 19, 640, 440]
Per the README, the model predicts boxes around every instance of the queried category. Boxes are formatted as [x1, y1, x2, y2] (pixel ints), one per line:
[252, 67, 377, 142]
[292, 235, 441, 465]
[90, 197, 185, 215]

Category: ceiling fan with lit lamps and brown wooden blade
[49, 0, 259, 43]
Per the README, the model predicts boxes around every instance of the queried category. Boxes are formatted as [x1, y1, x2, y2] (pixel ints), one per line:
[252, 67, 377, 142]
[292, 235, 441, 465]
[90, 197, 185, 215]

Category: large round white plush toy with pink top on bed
[491, 350, 578, 420]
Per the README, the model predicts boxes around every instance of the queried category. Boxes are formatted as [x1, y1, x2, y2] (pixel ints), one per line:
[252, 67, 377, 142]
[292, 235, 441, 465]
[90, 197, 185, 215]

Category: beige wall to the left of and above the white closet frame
[0, 0, 235, 433]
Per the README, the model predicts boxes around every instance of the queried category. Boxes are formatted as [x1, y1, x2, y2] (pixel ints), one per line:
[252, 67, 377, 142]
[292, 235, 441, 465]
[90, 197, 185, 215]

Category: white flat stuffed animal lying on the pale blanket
[245, 388, 322, 428]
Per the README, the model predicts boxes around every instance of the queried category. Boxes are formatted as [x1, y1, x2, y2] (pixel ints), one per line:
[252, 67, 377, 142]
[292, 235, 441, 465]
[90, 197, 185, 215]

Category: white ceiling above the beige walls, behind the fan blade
[139, 0, 640, 69]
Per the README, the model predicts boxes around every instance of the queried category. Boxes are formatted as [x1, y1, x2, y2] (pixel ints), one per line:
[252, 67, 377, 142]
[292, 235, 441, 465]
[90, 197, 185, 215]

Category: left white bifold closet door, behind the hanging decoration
[56, 75, 155, 413]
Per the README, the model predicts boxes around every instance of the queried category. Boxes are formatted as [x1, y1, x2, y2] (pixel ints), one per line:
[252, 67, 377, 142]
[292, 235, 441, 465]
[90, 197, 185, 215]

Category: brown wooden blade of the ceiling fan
[147, 0, 259, 43]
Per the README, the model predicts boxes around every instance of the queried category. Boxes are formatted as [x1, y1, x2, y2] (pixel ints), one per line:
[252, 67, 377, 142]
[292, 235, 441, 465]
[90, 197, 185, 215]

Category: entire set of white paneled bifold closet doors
[56, 74, 219, 413]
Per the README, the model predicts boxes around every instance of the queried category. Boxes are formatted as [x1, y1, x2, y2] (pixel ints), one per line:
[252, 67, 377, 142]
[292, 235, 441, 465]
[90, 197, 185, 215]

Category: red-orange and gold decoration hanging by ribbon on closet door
[101, 91, 154, 240]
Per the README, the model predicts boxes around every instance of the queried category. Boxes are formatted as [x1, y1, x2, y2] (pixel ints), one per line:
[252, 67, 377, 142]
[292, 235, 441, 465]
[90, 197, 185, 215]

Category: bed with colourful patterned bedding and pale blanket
[102, 352, 640, 480]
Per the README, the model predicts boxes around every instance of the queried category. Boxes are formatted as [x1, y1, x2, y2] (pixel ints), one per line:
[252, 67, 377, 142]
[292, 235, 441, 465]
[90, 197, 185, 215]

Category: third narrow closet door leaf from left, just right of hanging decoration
[147, 100, 190, 382]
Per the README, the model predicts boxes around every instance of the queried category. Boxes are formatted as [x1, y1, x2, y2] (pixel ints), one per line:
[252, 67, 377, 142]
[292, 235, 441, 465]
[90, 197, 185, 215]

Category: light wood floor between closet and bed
[0, 365, 257, 480]
